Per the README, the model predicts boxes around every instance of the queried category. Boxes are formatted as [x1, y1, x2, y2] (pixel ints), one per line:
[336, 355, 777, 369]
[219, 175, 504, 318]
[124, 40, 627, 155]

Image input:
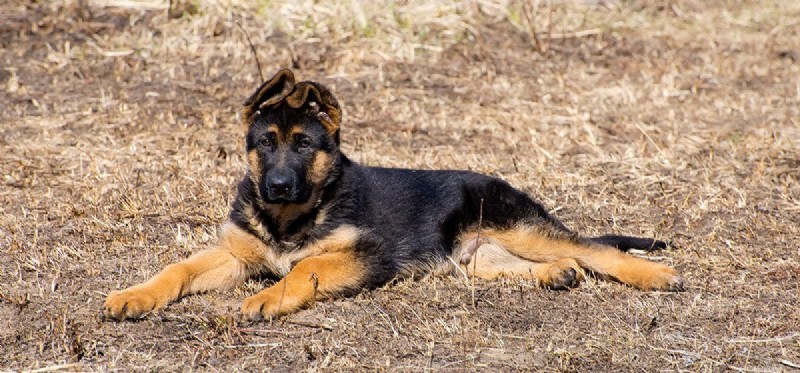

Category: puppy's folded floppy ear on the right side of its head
[286, 81, 342, 138]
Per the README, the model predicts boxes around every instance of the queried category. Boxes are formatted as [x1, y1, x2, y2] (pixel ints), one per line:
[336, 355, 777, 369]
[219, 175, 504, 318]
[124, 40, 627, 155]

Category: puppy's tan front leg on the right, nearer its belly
[242, 252, 367, 319]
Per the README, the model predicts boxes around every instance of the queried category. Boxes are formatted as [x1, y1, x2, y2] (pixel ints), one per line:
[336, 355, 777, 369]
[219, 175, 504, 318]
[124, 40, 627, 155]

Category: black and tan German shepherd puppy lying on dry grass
[104, 70, 683, 320]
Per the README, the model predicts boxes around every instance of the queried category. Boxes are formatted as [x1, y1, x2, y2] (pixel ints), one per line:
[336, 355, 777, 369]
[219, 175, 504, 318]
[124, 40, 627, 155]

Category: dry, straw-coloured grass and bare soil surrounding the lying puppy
[0, 0, 800, 371]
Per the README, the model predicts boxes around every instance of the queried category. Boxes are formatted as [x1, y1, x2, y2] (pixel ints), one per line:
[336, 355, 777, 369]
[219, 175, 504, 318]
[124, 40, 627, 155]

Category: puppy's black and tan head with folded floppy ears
[242, 70, 341, 204]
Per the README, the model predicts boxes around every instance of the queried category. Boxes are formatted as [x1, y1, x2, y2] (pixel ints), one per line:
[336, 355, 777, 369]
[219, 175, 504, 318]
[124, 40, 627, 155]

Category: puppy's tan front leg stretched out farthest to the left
[103, 224, 266, 320]
